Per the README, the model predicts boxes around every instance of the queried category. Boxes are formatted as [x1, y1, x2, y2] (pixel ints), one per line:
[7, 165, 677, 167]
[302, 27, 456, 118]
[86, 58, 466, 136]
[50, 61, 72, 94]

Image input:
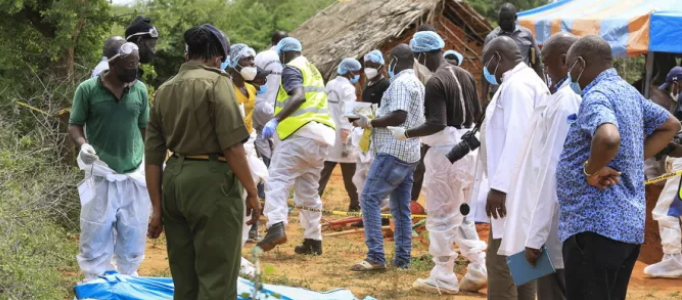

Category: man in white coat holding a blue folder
[497, 32, 581, 300]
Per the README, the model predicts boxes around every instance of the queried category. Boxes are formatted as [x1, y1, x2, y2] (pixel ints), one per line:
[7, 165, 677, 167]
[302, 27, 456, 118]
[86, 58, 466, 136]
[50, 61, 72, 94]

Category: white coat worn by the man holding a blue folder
[497, 81, 581, 268]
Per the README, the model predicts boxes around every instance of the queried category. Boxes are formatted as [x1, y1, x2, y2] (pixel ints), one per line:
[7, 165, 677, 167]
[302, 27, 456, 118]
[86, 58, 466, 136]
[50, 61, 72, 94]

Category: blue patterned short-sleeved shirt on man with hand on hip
[556, 69, 670, 244]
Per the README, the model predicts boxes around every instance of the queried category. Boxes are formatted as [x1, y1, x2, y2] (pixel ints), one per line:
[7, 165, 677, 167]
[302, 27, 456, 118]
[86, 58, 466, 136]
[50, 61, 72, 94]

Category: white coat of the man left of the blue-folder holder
[483, 63, 549, 239]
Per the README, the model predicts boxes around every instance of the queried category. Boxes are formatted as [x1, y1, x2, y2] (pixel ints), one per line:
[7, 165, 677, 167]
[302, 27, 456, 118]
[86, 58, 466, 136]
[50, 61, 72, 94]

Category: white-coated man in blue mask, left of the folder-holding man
[481, 36, 549, 300]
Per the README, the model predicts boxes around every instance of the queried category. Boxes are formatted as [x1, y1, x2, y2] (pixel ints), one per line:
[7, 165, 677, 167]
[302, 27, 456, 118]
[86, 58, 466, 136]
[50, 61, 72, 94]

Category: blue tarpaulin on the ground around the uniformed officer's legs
[74, 272, 376, 300]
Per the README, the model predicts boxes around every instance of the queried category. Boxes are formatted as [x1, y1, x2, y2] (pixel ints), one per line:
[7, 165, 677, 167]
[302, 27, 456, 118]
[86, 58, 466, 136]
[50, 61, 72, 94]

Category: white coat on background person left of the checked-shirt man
[326, 76, 358, 163]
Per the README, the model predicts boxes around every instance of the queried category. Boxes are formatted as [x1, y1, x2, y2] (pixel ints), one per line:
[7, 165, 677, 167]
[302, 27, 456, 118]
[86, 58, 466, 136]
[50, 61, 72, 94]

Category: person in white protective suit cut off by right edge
[644, 67, 682, 278]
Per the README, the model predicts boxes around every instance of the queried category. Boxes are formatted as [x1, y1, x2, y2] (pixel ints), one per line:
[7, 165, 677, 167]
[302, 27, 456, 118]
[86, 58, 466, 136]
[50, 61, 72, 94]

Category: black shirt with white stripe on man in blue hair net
[424, 64, 481, 128]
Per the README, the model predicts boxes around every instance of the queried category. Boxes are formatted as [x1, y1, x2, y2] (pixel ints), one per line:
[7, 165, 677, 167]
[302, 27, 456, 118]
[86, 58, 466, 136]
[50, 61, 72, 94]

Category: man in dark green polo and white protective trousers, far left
[69, 40, 151, 282]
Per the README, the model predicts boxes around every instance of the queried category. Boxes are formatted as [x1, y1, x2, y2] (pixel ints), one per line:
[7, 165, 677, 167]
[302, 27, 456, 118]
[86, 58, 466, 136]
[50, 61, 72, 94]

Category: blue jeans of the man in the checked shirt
[360, 153, 417, 268]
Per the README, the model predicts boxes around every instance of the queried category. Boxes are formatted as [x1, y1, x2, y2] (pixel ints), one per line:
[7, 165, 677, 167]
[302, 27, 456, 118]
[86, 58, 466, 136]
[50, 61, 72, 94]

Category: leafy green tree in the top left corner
[0, 0, 109, 104]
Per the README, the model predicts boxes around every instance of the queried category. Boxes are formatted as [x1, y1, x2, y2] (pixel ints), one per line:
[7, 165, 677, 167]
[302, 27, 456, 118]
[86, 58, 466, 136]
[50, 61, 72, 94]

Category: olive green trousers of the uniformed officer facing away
[162, 156, 244, 300]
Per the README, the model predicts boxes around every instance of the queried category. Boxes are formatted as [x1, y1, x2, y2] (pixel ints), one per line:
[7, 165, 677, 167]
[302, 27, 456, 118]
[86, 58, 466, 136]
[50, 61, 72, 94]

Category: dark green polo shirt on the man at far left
[69, 76, 149, 174]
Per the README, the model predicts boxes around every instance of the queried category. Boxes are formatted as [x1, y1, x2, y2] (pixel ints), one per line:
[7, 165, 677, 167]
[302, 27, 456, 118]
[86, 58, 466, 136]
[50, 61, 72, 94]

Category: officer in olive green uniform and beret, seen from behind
[145, 24, 260, 300]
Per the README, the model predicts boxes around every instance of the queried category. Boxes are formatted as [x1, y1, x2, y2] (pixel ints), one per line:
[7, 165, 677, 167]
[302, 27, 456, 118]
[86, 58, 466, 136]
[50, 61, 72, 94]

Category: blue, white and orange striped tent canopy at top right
[519, 0, 682, 57]
